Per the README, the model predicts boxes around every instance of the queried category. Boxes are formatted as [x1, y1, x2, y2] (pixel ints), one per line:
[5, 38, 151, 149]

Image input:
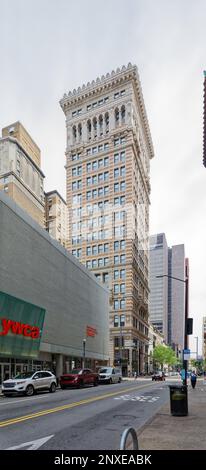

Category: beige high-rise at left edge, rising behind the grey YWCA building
[0, 122, 44, 226]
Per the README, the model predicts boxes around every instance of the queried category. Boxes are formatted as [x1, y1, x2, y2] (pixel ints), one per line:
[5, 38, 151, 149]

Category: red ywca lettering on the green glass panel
[0, 318, 40, 339]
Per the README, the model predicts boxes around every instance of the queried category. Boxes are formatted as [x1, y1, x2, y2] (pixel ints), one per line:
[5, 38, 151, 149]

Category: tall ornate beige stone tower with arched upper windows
[60, 64, 154, 373]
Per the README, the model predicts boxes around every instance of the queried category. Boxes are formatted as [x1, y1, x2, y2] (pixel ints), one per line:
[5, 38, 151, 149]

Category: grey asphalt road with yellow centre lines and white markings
[0, 379, 169, 450]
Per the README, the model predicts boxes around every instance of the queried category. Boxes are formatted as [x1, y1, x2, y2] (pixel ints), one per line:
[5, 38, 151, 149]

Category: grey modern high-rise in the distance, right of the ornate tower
[149, 233, 189, 352]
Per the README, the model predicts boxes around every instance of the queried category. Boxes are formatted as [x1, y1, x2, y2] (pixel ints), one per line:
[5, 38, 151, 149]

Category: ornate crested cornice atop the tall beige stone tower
[60, 63, 154, 158]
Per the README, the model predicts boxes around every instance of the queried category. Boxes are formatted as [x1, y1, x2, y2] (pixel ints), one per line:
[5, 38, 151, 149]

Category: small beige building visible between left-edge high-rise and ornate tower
[45, 190, 67, 246]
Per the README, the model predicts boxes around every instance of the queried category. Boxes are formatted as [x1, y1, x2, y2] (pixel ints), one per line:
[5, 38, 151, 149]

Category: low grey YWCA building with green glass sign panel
[0, 191, 109, 380]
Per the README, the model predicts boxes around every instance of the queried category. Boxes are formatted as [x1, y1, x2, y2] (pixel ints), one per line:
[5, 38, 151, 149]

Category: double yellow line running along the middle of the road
[0, 384, 151, 428]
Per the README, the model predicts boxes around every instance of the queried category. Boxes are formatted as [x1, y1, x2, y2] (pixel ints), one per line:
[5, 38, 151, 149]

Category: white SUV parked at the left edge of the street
[2, 370, 57, 397]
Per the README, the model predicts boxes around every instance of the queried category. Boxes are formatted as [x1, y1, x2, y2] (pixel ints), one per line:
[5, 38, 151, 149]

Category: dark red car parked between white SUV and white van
[59, 369, 99, 389]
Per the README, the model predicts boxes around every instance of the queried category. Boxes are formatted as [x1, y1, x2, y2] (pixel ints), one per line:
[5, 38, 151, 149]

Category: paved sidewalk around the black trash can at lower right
[138, 379, 206, 450]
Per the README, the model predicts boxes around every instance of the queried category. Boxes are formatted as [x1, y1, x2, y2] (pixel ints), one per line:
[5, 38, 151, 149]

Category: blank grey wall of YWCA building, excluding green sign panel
[0, 191, 109, 359]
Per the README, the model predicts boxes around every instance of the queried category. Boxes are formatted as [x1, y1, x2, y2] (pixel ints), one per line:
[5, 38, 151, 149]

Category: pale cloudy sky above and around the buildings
[0, 0, 206, 353]
